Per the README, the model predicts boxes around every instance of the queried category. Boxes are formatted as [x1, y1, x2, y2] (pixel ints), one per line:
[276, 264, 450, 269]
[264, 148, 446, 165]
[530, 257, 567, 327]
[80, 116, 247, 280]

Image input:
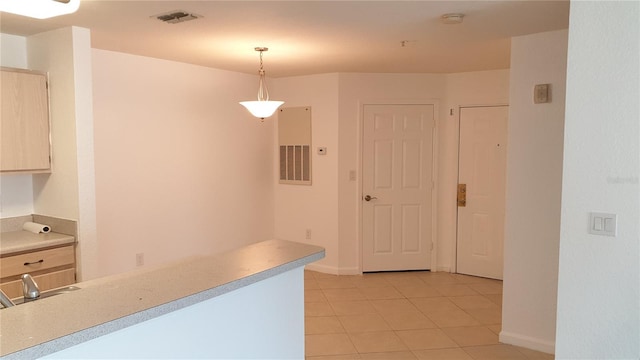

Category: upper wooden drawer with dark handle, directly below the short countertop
[0, 246, 75, 278]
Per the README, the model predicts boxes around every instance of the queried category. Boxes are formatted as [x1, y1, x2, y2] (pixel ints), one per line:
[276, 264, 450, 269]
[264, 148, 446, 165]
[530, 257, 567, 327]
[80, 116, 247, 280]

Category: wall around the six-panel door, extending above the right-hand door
[337, 69, 509, 273]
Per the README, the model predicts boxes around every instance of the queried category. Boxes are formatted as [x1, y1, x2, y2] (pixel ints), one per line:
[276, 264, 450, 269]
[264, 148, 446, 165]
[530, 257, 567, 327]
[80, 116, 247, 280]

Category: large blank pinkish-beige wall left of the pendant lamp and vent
[93, 49, 274, 275]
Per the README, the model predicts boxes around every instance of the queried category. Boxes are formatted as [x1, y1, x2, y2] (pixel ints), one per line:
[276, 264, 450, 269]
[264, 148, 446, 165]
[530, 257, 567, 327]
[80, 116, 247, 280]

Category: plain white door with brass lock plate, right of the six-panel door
[457, 106, 509, 279]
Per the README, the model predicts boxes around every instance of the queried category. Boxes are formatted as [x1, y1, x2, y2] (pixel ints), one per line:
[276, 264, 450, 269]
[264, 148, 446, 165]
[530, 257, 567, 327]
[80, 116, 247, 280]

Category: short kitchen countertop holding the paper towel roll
[0, 230, 75, 256]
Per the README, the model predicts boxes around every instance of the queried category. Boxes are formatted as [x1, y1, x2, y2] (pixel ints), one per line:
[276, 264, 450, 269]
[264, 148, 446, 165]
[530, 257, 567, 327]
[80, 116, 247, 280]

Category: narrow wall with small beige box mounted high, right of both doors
[500, 30, 567, 353]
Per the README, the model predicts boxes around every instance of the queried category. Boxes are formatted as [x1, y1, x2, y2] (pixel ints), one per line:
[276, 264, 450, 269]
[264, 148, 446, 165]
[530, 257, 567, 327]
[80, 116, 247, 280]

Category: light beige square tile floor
[305, 271, 553, 360]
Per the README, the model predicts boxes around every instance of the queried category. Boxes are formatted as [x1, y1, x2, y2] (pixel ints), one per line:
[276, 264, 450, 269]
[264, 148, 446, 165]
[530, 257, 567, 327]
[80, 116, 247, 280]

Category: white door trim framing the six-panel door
[353, 98, 440, 274]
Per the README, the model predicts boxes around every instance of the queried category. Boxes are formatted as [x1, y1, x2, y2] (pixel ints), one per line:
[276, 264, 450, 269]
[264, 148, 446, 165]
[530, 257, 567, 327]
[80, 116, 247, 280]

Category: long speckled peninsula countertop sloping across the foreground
[0, 240, 324, 359]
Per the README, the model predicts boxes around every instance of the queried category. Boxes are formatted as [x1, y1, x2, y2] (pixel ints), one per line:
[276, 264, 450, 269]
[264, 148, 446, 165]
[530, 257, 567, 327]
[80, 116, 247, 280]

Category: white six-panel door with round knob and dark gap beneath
[362, 105, 435, 271]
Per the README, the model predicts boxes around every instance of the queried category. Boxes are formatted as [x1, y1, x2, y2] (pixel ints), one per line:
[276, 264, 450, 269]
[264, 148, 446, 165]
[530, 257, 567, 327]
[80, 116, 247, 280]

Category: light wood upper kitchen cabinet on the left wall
[0, 68, 51, 173]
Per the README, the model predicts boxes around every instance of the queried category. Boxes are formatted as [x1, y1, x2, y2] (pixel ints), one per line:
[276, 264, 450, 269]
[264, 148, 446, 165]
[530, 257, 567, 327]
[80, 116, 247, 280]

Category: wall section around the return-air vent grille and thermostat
[272, 74, 339, 272]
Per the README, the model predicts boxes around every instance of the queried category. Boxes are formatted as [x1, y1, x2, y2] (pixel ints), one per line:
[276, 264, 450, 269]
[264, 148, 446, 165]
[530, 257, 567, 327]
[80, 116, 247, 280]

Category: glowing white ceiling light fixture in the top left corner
[0, 0, 80, 19]
